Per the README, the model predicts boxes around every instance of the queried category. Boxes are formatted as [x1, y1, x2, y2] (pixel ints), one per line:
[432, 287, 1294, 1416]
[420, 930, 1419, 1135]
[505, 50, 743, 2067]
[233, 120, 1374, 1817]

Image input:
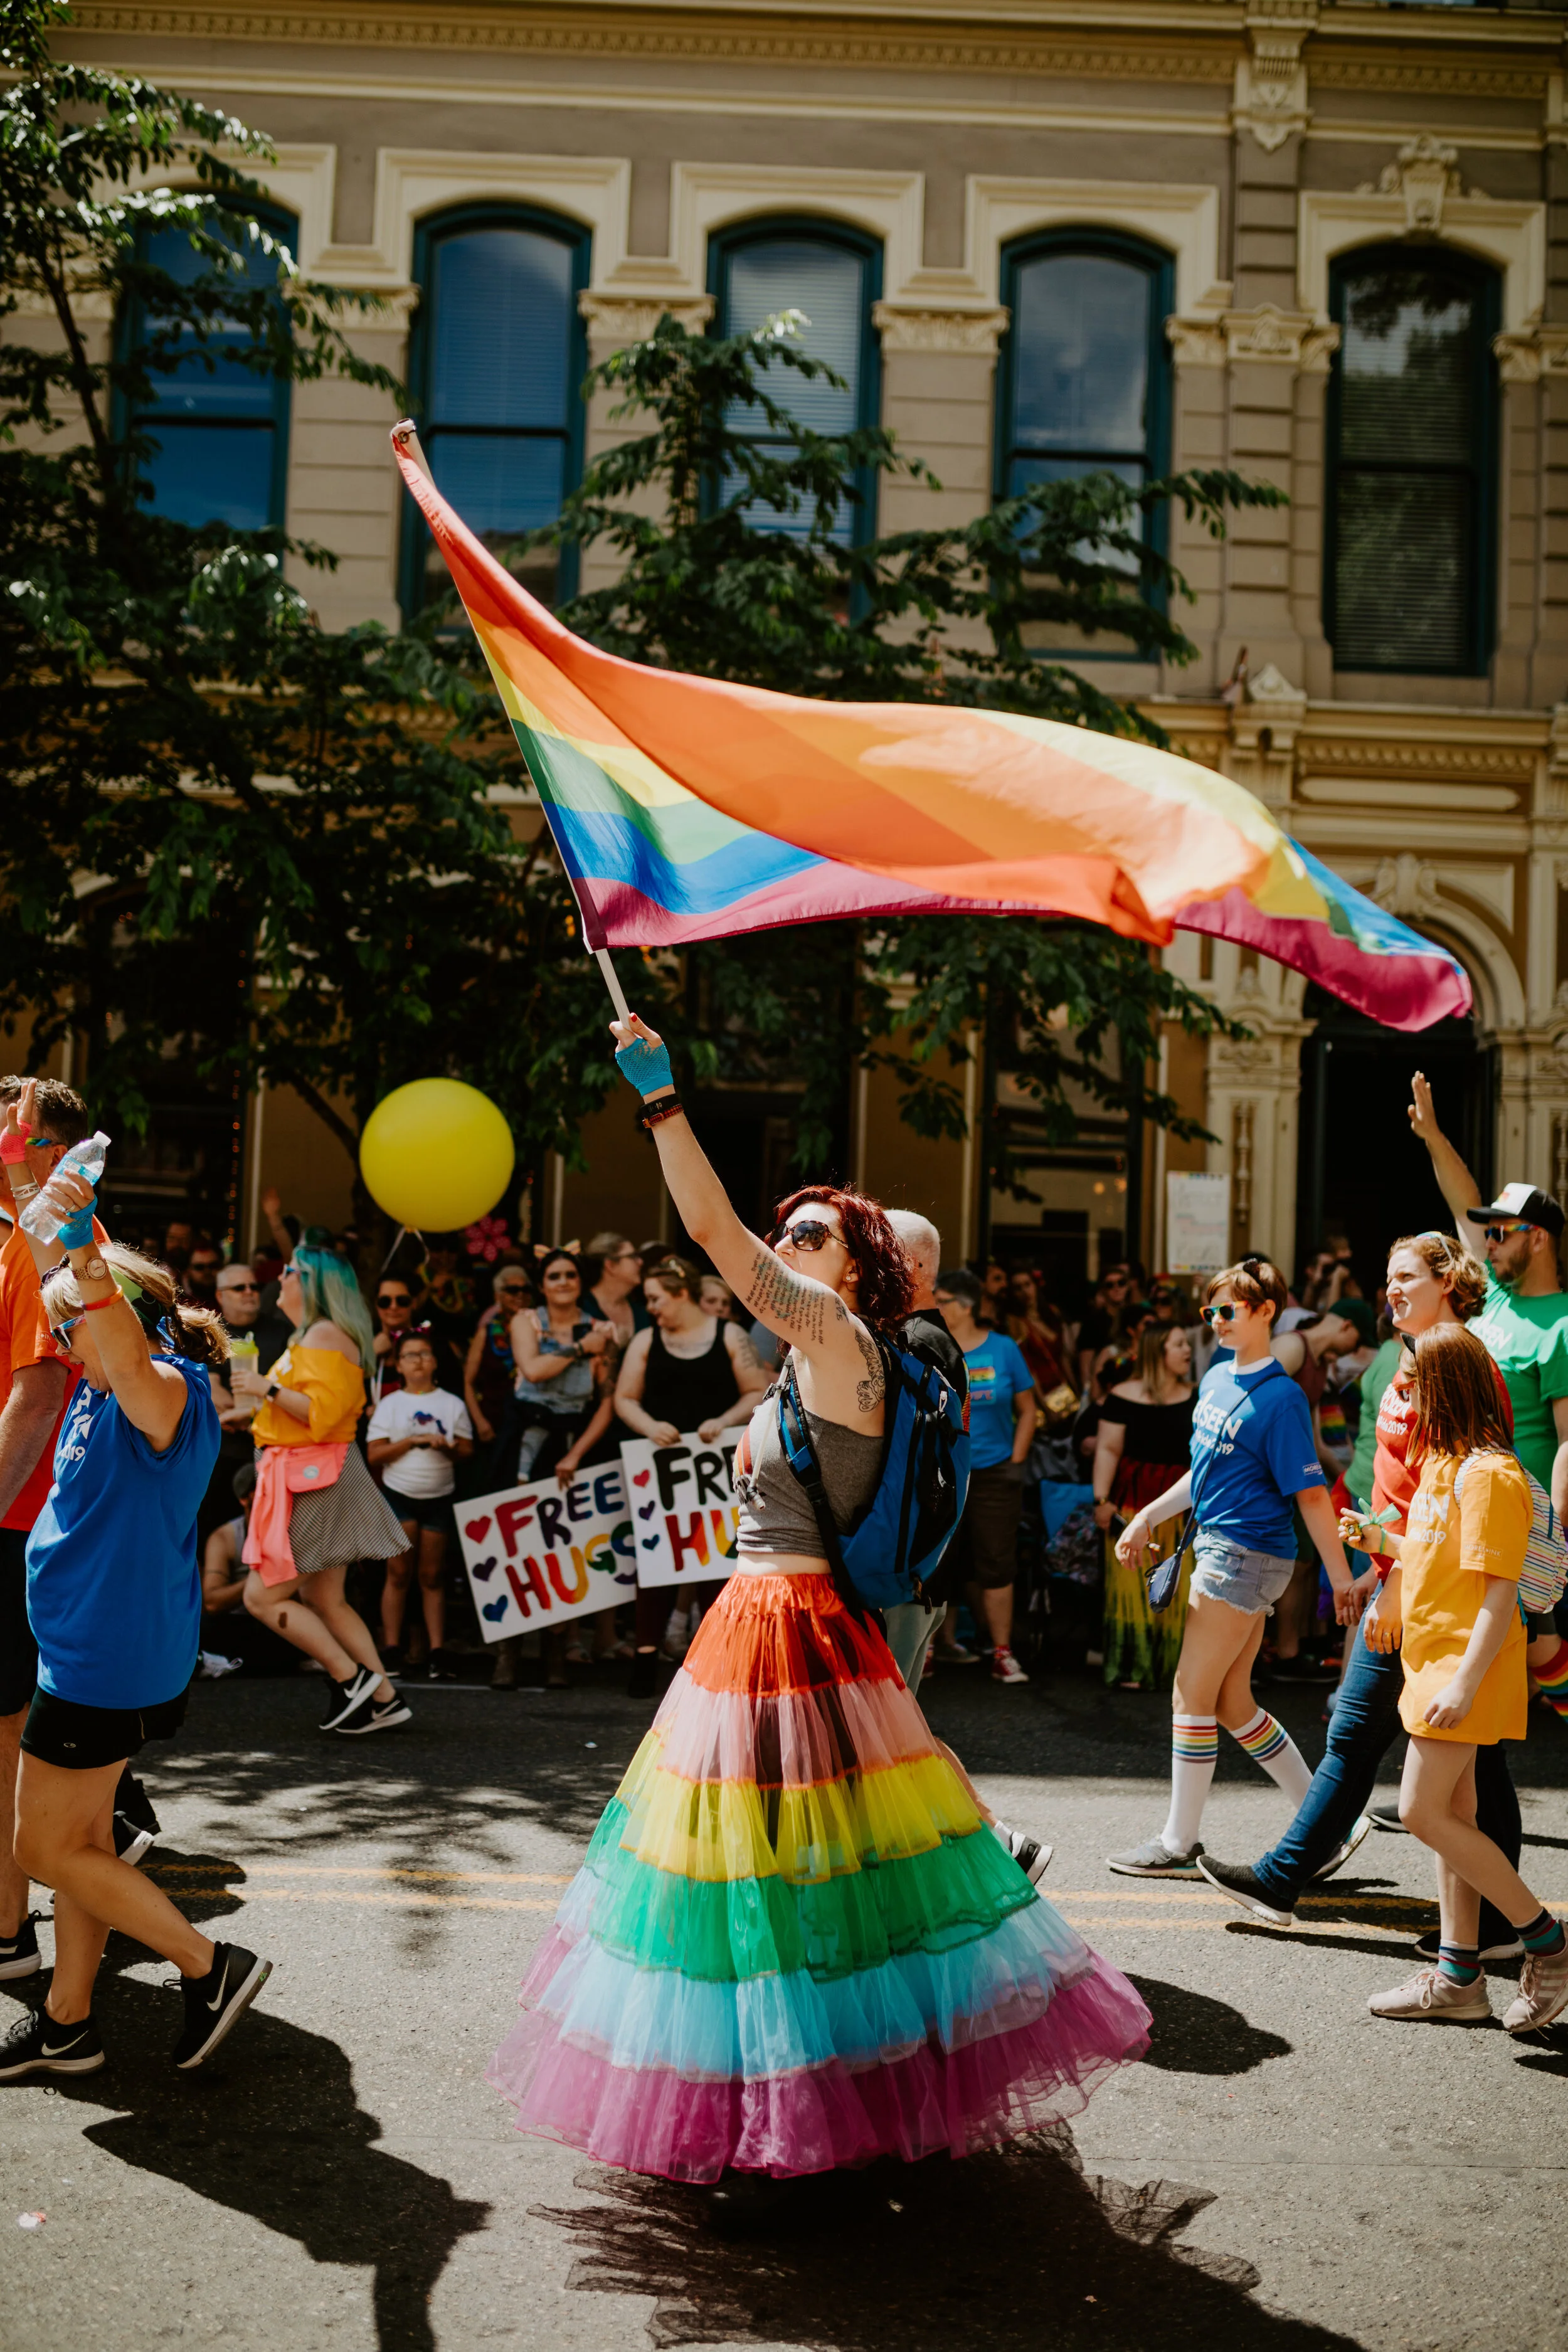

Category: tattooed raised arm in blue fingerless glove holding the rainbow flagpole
[612, 1014, 882, 1418]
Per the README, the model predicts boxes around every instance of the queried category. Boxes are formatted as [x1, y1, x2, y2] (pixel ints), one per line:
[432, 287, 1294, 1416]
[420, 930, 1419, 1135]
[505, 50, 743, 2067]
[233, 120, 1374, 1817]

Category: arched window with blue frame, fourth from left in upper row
[994, 228, 1175, 602]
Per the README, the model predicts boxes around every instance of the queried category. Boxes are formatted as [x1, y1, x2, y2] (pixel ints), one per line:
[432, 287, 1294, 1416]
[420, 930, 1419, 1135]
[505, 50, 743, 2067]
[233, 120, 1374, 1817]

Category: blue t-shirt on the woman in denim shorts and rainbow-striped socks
[1192, 1355, 1328, 1559]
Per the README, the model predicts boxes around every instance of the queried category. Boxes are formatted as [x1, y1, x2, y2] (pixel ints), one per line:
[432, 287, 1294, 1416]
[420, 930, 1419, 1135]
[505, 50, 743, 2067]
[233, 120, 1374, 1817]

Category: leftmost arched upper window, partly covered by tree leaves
[125, 204, 299, 532]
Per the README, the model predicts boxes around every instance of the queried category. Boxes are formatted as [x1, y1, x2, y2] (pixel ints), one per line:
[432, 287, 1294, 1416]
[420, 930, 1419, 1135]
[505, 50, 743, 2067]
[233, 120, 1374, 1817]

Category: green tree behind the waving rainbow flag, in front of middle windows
[529, 313, 1281, 1190]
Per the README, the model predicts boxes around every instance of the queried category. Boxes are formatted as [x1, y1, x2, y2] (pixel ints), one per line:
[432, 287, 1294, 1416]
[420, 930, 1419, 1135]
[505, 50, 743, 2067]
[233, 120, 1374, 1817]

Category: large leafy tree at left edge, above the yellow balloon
[0, 0, 613, 1251]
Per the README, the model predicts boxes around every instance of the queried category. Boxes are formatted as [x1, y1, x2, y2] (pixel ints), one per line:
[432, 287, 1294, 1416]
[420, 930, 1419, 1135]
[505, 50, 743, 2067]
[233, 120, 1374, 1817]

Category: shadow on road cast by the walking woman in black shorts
[7, 1853, 489, 2352]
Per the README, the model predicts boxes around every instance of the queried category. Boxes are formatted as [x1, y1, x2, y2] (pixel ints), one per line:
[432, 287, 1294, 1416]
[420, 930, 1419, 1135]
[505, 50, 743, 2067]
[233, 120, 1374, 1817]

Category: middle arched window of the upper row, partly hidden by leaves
[707, 219, 882, 546]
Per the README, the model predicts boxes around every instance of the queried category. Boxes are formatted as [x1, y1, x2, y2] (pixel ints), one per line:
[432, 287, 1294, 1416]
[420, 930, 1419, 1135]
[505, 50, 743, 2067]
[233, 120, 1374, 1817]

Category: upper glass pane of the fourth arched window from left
[1011, 254, 1152, 449]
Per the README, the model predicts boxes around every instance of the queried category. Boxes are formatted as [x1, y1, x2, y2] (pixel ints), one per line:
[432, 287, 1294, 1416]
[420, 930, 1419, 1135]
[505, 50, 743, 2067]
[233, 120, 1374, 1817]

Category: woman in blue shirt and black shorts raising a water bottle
[0, 1087, 270, 2082]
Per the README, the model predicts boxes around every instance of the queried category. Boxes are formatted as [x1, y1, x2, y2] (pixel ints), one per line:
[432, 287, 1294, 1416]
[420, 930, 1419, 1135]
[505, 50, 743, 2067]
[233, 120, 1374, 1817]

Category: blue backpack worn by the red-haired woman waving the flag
[778, 1333, 968, 1609]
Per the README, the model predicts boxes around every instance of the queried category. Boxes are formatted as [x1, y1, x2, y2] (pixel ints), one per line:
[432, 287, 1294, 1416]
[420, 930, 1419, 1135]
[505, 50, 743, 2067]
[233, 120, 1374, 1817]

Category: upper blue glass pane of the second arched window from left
[430, 228, 574, 433]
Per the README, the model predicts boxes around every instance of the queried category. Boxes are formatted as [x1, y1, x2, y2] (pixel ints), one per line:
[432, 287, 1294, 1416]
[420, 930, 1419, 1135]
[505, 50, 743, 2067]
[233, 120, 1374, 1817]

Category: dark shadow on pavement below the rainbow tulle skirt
[534, 2129, 1354, 2352]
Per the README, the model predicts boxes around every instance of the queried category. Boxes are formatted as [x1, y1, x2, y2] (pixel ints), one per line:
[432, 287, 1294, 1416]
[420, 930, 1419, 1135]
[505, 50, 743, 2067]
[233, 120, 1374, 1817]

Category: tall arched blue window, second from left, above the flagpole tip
[402, 204, 593, 614]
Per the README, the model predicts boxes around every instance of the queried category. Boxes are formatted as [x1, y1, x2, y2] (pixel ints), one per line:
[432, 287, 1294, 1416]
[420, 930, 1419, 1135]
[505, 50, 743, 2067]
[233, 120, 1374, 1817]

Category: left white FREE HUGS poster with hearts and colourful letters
[456, 1463, 637, 1642]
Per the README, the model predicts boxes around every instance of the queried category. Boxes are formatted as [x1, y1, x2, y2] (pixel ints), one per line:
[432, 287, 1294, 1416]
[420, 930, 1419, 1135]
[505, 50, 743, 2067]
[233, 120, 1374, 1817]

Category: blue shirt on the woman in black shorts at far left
[28, 1355, 221, 1708]
